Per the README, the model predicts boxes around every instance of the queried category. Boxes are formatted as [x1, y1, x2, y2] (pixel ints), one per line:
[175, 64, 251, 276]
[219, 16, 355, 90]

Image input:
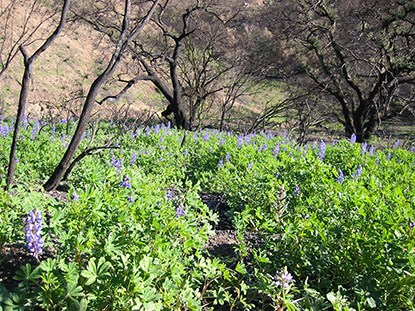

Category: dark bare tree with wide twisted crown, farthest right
[267, 0, 415, 142]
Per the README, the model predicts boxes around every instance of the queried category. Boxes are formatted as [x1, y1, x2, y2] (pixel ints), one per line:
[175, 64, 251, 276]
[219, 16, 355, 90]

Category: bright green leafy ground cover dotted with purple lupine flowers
[0, 121, 415, 310]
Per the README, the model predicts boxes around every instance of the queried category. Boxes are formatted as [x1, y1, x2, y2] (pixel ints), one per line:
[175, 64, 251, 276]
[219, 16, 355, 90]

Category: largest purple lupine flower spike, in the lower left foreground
[25, 208, 43, 259]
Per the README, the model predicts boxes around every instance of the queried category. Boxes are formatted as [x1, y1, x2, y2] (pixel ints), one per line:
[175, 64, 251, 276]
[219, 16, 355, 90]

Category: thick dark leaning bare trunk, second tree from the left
[44, 0, 160, 191]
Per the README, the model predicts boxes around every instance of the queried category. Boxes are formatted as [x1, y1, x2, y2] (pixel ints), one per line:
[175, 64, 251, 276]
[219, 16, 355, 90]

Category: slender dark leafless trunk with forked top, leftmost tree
[6, 0, 70, 189]
